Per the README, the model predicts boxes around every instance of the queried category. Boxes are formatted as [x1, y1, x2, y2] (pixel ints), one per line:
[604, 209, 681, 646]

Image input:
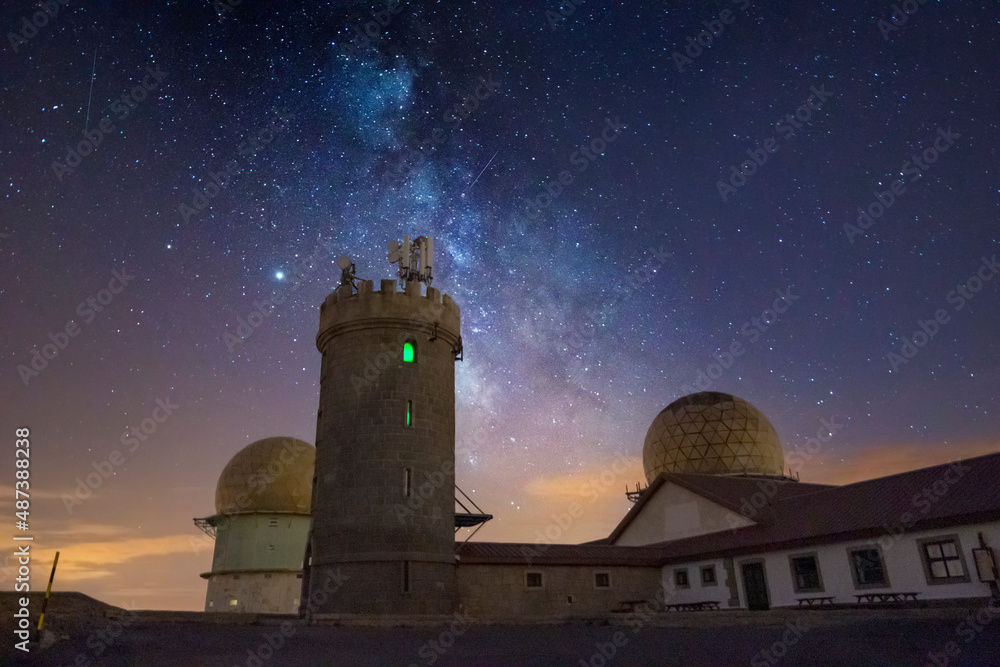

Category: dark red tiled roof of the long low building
[456, 453, 1000, 565]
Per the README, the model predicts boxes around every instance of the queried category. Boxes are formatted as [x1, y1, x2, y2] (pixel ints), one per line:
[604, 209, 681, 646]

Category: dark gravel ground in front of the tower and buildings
[0, 610, 1000, 667]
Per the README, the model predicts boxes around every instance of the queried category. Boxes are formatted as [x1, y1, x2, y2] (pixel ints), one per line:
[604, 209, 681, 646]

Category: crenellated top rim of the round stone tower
[316, 279, 461, 350]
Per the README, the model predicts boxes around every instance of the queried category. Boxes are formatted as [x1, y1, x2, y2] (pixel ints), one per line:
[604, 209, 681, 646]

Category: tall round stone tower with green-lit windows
[300, 264, 462, 615]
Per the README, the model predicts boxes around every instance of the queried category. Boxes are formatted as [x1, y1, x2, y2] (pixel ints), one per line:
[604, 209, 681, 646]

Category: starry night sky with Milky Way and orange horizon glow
[0, 0, 1000, 609]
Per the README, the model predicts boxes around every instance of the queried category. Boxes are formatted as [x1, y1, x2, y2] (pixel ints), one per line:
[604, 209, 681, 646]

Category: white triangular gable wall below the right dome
[615, 482, 754, 546]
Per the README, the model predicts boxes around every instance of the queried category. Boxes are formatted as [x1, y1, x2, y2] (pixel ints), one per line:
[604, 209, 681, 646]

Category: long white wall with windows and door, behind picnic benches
[704, 522, 1000, 608]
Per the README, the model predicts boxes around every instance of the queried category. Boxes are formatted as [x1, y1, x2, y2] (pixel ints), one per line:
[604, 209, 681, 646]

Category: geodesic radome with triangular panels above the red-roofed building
[642, 391, 785, 483]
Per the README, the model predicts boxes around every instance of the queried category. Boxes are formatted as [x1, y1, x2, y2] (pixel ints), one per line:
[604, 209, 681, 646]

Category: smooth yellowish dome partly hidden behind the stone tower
[215, 437, 316, 515]
